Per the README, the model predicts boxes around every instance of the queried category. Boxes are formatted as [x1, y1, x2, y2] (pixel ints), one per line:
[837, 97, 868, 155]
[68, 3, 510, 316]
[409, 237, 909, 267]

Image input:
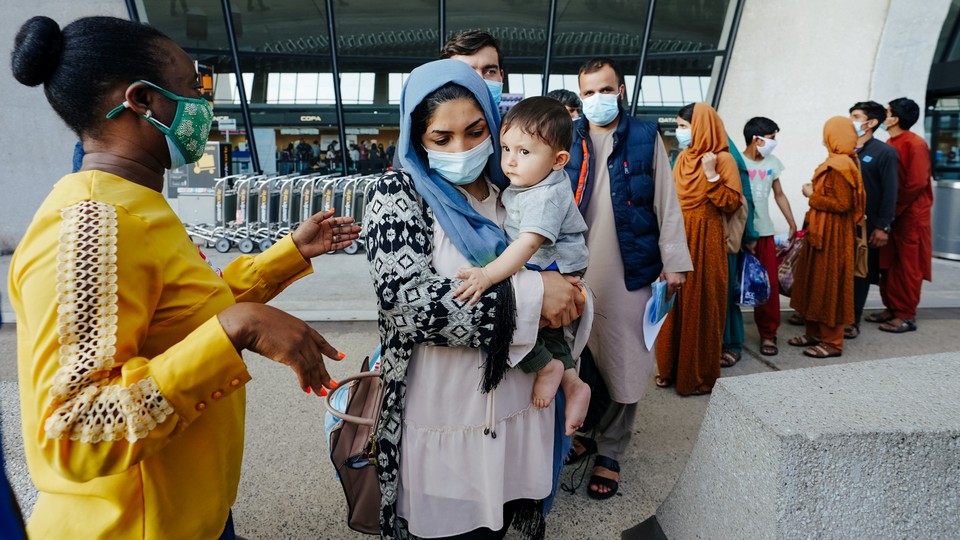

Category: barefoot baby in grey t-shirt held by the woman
[455, 97, 590, 435]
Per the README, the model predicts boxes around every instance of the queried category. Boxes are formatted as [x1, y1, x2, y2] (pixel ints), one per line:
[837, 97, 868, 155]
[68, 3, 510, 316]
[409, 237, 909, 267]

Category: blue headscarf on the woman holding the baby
[397, 59, 507, 266]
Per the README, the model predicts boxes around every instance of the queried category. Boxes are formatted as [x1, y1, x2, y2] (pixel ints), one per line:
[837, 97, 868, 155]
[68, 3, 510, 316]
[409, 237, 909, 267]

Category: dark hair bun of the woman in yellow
[10, 16, 63, 86]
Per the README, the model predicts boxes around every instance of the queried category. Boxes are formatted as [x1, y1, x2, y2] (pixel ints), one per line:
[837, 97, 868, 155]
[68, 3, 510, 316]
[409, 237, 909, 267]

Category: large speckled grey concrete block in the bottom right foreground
[656, 353, 960, 540]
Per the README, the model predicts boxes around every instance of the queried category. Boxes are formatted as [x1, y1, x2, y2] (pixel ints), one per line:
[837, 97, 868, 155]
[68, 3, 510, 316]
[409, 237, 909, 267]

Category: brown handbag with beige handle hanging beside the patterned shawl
[323, 358, 383, 534]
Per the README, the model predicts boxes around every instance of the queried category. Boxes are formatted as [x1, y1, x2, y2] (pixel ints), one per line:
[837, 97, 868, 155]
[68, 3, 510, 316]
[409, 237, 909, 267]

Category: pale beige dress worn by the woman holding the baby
[397, 184, 555, 538]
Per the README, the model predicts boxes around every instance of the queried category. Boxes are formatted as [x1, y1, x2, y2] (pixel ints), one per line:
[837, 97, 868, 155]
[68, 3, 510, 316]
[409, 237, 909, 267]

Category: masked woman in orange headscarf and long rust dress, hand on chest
[657, 103, 743, 395]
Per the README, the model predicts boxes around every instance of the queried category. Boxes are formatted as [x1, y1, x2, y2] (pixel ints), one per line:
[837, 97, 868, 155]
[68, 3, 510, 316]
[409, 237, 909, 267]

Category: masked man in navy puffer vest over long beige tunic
[566, 58, 693, 499]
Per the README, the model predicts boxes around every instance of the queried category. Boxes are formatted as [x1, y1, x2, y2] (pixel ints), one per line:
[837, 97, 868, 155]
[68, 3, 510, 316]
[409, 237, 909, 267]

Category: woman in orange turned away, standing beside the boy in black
[789, 116, 865, 358]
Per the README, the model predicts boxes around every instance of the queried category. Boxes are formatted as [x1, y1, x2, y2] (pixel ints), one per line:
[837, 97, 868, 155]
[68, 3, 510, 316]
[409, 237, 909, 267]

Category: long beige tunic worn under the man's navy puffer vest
[584, 131, 693, 403]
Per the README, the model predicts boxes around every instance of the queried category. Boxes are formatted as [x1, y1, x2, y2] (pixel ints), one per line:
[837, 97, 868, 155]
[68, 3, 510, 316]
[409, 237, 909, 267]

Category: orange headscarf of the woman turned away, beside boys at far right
[807, 116, 867, 248]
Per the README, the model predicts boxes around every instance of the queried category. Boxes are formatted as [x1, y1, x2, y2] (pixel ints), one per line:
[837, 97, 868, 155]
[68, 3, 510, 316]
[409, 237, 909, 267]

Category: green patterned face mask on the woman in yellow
[107, 81, 213, 169]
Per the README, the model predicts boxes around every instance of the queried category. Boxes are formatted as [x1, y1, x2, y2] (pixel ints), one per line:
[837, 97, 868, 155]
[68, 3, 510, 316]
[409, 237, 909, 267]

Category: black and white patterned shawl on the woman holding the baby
[363, 171, 516, 539]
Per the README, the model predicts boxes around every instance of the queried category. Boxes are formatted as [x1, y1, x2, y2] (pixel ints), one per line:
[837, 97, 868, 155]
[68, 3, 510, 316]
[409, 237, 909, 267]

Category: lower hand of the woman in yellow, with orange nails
[217, 303, 343, 395]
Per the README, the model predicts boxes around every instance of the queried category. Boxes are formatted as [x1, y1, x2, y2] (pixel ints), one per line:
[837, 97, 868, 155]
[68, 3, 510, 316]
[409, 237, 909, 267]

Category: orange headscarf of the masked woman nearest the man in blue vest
[673, 103, 743, 210]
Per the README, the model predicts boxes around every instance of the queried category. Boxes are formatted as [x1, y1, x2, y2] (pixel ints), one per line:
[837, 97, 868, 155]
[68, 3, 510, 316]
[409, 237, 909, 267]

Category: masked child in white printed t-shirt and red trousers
[743, 116, 797, 356]
